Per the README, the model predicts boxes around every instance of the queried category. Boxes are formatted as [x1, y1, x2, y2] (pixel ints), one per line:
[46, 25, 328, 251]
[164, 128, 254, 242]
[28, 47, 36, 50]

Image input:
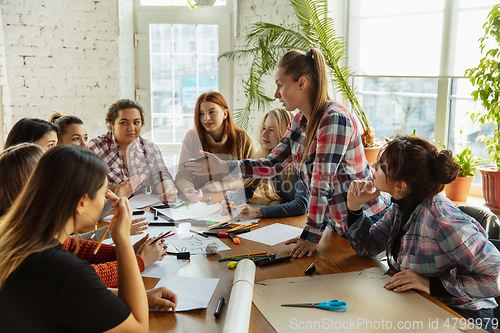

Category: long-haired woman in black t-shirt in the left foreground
[0, 145, 175, 332]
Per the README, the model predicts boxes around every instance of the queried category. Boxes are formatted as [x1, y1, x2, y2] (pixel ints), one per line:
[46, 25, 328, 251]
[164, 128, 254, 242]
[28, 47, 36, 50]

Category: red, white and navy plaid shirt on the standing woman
[228, 101, 387, 244]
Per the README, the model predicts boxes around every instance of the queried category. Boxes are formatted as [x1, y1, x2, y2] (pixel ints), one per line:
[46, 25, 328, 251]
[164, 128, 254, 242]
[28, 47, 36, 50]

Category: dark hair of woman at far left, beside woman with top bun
[3, 118, 57, 149]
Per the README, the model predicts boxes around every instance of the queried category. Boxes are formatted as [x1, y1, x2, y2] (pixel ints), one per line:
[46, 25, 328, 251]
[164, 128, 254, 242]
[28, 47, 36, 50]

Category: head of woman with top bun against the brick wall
[48, 111, 89, 147]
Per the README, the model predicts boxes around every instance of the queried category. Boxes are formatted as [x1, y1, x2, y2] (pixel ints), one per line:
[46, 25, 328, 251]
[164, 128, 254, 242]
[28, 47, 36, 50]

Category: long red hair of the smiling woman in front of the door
[194, 91, 243, 154]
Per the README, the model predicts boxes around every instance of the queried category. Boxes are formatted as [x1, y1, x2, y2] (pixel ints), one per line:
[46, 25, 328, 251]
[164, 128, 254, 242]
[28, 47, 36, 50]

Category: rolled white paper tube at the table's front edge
[222, 259, 255, 333]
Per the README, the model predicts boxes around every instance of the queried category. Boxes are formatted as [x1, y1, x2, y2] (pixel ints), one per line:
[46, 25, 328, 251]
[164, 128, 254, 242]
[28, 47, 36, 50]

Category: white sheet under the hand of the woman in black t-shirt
[151, 276, 219, 312]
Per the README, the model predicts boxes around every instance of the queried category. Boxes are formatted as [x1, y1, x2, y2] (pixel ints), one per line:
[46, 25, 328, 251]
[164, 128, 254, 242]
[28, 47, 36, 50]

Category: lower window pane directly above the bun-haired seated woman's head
[355, 77, 437, 140]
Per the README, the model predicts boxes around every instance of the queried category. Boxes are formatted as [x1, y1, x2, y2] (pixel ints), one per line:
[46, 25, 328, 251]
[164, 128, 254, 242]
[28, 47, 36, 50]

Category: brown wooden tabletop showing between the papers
[143, 196, 458, 333]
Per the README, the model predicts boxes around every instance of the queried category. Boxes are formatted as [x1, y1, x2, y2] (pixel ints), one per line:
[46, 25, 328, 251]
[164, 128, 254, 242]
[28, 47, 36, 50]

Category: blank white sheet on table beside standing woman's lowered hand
[238, 223, 302, 246]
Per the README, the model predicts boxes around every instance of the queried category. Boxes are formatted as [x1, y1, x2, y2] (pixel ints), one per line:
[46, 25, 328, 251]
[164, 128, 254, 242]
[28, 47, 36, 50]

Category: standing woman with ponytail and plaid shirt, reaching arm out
[188, 48, 387, 258]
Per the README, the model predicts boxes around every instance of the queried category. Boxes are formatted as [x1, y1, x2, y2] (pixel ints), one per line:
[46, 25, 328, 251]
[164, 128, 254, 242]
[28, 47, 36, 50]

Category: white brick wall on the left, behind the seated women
[0, 0, 125, 137]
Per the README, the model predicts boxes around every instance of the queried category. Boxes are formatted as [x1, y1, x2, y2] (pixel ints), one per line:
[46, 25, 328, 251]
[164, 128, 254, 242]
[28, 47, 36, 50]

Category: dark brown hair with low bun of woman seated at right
[379, 135, 460, 199]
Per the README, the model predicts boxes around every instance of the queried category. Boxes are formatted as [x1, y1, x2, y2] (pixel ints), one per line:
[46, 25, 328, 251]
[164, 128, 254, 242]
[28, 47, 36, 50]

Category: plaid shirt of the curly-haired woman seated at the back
[89, 131, 173, 192]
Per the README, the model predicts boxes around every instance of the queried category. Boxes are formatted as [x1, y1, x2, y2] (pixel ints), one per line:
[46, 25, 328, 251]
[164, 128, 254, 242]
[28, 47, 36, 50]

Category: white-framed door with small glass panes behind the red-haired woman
[136, 0, 232, 154]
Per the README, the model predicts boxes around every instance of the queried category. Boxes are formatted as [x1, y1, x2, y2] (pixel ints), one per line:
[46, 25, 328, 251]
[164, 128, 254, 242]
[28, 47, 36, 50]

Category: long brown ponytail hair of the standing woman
[278, 48, 330, 162]
